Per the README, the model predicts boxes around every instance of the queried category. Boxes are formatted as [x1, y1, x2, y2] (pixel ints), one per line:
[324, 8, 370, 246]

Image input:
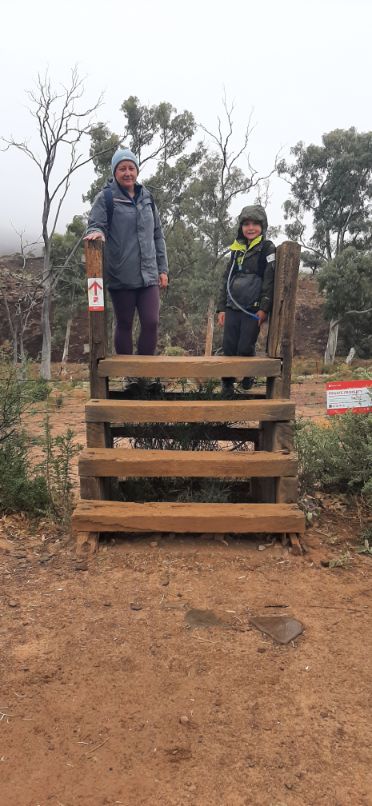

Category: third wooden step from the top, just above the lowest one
[79, 448, 297, 479]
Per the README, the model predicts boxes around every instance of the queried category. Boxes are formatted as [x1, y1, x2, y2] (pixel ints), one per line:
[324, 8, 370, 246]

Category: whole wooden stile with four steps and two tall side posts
[73, 234, 305, 552]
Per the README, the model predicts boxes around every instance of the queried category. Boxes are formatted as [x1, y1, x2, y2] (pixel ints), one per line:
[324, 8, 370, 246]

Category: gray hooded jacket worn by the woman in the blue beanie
[87, 179, 168, 289]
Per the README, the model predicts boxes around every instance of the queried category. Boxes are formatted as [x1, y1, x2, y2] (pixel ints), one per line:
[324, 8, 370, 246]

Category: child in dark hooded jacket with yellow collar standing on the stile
[217, 204, 275, 398]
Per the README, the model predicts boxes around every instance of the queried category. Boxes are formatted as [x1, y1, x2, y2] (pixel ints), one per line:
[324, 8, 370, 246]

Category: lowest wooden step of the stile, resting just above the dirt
[72, 501, 305, 534]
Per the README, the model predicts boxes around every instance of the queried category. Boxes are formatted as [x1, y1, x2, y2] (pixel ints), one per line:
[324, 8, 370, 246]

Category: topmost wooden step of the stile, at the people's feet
[98, 355, 281, 378]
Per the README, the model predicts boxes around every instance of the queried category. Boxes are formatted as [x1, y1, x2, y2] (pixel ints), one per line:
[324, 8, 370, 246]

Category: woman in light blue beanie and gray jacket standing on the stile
[86, 148, 168, 392]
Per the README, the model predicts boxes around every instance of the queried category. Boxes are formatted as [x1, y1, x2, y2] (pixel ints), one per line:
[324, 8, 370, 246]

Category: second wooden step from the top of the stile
[85, 400, 295, 423]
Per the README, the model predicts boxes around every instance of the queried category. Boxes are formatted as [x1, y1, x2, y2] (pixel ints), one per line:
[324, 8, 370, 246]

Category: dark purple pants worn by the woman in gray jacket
[110, 285, 160, 355]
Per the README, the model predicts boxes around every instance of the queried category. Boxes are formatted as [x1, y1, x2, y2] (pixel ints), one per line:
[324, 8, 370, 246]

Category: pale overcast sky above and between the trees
[0, 0, 372, 254]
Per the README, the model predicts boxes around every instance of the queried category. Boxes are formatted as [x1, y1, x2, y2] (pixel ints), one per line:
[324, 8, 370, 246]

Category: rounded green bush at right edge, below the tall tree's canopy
[318, 247, 372, 358]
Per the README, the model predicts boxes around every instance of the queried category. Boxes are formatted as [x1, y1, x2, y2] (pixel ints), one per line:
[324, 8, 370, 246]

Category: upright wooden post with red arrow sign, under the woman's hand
[84, 240, 108, 398]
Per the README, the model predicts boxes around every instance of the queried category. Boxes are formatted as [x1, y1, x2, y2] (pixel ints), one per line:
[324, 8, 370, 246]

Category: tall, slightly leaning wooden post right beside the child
[267, 241, 301, 398]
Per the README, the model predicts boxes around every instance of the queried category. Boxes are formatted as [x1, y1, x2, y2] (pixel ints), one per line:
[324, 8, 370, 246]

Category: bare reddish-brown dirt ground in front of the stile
[0, 370, 372, 806]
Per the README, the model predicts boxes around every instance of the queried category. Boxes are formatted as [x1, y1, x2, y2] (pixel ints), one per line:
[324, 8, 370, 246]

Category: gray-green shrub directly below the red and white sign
[296, 412, 372, 505]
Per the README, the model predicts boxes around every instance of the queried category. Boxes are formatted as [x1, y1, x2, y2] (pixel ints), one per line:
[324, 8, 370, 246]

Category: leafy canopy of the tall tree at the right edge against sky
[278, 128, 372, 260]
